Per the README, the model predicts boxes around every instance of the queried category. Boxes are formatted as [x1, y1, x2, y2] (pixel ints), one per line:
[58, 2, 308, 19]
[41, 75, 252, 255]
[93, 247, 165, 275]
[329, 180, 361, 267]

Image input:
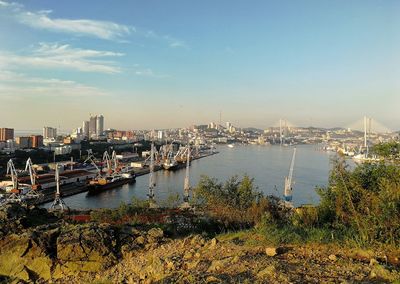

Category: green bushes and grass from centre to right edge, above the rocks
[191, 155, 400, 248]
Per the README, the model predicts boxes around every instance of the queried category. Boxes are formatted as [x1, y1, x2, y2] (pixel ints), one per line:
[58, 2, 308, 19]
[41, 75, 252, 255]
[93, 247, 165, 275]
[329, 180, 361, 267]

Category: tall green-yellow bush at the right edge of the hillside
[317, 160, 400, 246]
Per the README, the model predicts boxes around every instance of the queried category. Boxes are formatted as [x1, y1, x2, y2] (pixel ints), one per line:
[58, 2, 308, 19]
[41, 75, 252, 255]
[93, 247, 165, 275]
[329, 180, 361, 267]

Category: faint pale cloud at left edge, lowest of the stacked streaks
[0, 71, 108, 100]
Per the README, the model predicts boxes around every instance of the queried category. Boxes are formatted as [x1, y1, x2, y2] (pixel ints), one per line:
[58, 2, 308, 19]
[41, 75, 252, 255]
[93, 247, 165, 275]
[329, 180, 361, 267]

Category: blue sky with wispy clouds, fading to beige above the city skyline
[0, 0, 400, 130]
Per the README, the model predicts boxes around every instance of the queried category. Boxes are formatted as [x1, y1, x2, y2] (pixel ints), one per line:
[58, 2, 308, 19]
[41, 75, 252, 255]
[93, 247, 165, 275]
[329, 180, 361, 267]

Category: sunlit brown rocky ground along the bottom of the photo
[0, 203, 400, 283]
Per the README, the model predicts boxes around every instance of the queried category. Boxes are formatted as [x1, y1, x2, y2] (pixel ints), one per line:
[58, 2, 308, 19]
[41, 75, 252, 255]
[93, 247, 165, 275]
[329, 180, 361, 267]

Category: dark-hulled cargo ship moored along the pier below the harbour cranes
[88, 173, 136, 194]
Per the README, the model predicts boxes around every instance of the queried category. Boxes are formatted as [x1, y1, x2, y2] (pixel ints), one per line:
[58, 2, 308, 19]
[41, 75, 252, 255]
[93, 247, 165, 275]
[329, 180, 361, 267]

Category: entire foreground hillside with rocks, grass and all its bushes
[0, 143, 400, 283]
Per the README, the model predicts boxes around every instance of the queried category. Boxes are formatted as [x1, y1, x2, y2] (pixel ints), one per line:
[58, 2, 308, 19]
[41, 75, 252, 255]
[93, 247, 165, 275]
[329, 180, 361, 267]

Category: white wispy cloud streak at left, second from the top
[0, 43, 124, 74]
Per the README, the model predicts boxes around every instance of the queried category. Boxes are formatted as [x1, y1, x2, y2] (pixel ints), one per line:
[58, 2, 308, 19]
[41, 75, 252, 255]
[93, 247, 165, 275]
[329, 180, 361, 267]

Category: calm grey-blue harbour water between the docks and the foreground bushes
[45, 145, 331, 208]
